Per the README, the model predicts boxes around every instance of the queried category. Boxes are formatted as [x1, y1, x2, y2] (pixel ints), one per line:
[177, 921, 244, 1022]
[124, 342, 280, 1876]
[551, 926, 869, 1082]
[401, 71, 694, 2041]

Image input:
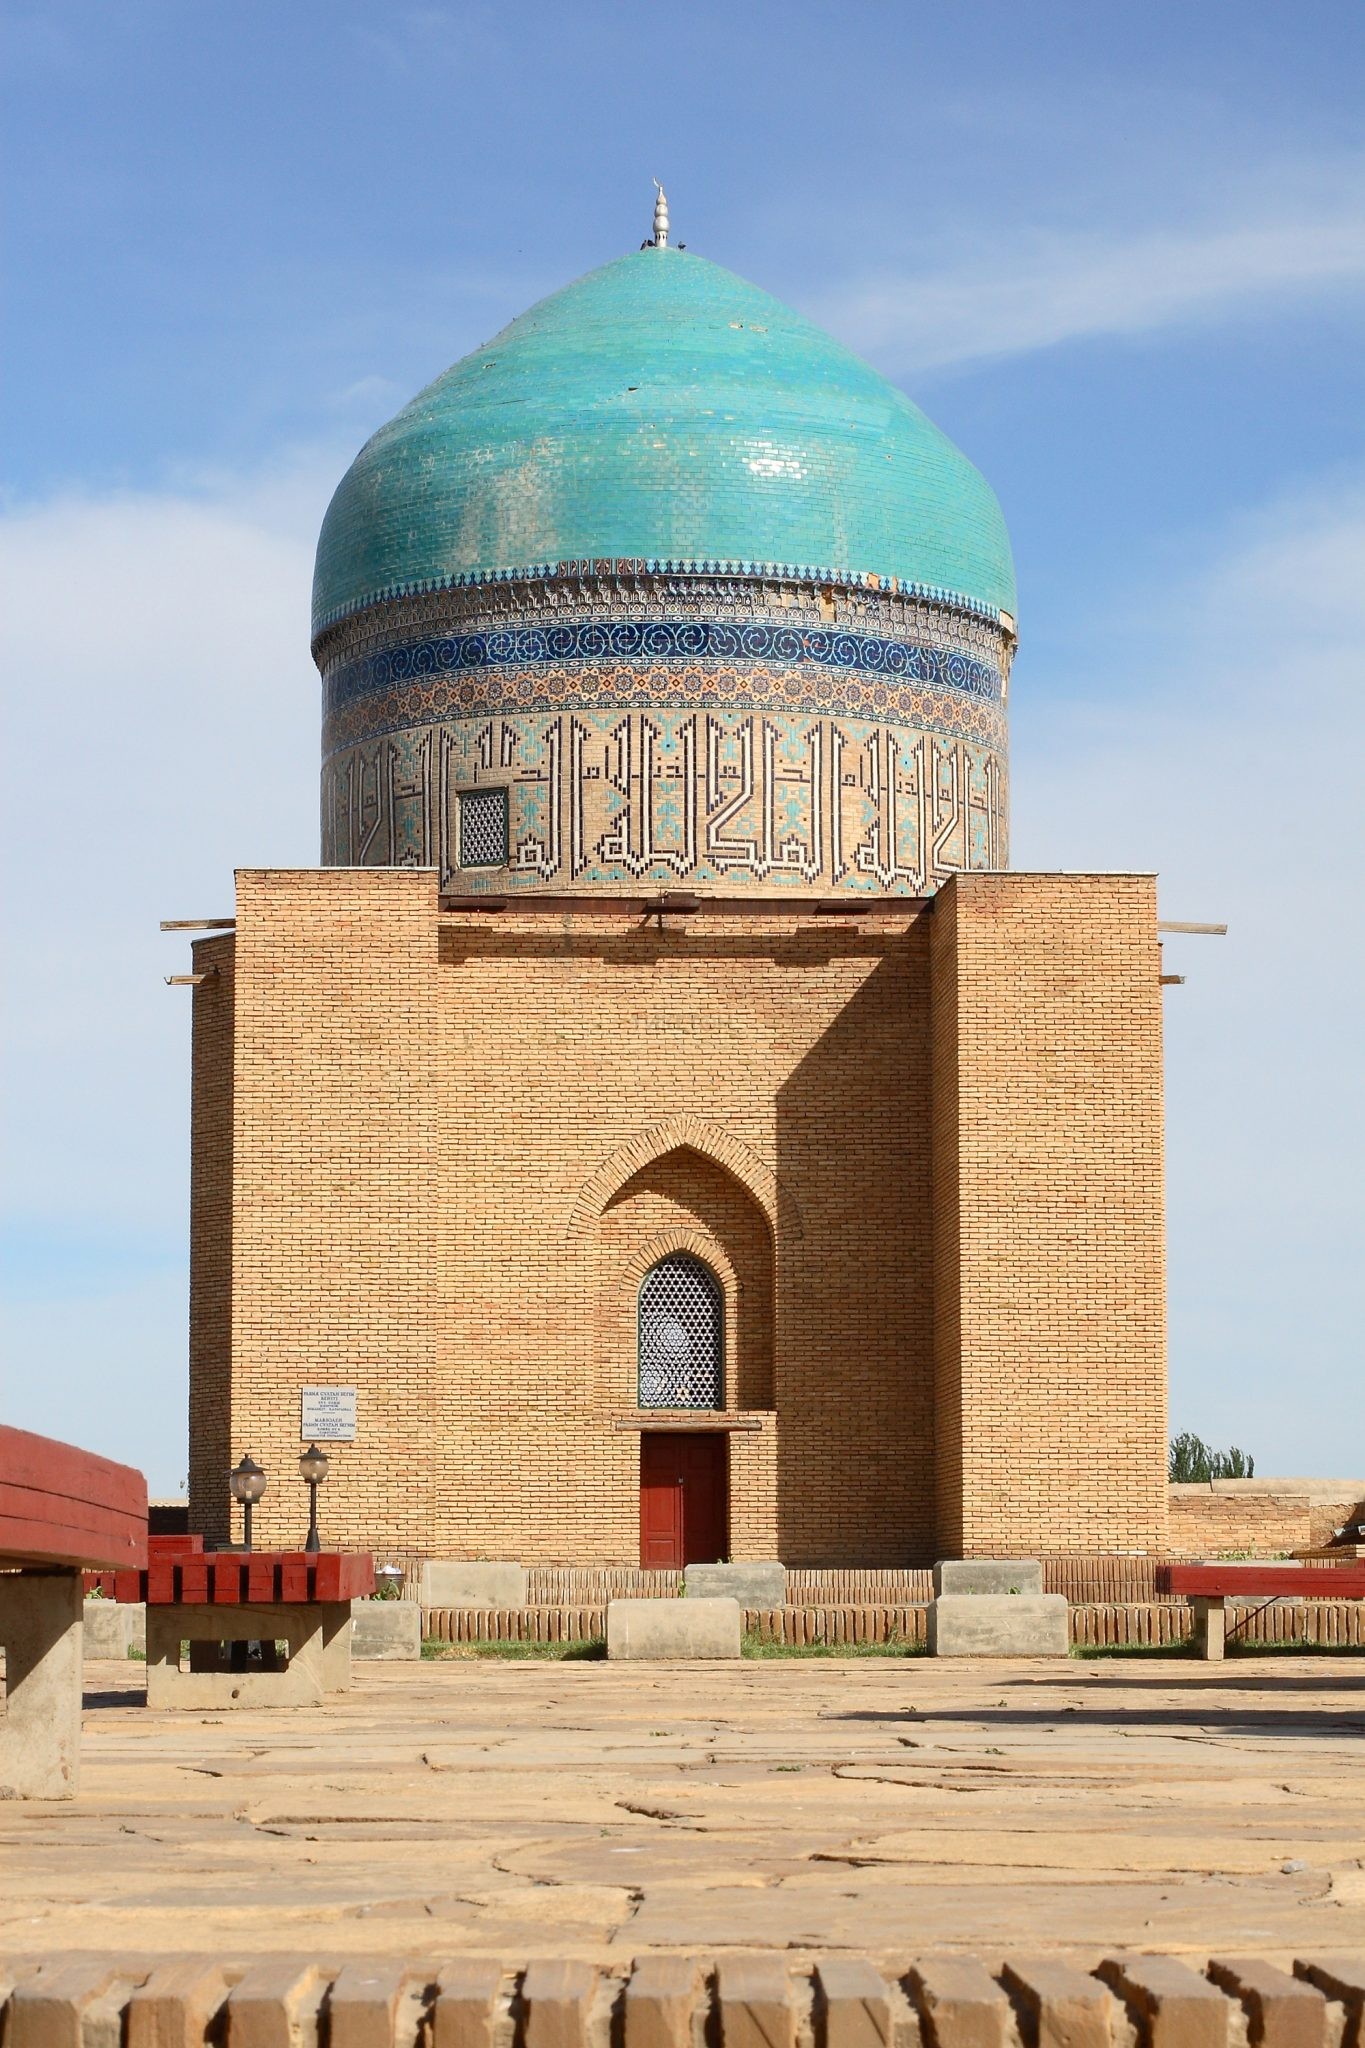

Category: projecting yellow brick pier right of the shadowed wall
[931, 874, 1166, 1556]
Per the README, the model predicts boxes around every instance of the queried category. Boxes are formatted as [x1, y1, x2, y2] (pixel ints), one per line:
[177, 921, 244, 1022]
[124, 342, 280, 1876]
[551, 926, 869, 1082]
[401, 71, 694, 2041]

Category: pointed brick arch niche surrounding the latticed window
[596, 1145, 774, 1413]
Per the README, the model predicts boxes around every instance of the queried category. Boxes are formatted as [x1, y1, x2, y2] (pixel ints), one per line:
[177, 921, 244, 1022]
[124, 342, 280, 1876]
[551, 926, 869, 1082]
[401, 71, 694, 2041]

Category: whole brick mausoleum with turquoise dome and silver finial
[181, 203, 1166, 1565]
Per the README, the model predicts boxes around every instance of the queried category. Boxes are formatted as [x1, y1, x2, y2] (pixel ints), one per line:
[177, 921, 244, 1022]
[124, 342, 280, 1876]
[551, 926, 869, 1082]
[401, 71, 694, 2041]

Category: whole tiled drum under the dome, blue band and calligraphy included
[317, 563, 1011, 895]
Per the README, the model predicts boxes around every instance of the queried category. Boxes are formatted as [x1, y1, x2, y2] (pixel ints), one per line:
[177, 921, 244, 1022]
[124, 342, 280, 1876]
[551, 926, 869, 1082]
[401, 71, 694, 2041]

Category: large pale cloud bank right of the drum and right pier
[1011, 479, 1365, 1477]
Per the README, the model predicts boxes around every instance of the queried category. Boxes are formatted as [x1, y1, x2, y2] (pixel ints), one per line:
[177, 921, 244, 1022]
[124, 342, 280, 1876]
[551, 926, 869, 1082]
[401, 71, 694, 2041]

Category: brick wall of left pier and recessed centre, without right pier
[194, 870, 933, 1563]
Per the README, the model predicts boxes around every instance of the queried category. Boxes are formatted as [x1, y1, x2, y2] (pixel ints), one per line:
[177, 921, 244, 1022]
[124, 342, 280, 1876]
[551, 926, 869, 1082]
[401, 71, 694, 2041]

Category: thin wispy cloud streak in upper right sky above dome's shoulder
[821, 175, 1365, 375]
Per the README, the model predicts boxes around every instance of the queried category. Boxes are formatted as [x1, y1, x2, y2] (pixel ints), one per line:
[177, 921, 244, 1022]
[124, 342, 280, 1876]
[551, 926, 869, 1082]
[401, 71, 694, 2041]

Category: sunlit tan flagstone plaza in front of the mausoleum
[0, 1657, 1365, 1960]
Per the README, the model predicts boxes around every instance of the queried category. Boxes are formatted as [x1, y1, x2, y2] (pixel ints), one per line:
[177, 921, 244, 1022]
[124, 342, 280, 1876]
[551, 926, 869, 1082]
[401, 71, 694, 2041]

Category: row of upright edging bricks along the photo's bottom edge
[0, 1952, 1365, 2048]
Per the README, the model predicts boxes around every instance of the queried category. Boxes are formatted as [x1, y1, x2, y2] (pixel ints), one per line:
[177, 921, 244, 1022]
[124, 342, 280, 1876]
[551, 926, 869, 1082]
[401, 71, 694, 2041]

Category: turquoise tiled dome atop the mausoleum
[313, 248, 1015, 631]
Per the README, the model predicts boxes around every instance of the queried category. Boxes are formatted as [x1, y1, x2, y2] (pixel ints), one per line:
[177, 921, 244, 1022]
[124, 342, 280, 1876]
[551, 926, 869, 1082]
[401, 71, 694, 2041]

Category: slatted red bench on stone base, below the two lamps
[113, 1536, 375, 1710]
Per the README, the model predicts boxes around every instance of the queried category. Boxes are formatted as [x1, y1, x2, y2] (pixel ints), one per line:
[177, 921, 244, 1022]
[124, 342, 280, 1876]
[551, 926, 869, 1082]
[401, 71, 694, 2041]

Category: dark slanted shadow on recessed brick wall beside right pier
[776, 915, 935, 1567]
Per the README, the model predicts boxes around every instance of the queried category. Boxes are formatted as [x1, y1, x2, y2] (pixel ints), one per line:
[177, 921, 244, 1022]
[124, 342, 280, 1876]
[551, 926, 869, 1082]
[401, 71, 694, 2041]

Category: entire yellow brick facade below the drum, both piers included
[190, 868, 1166, 1565]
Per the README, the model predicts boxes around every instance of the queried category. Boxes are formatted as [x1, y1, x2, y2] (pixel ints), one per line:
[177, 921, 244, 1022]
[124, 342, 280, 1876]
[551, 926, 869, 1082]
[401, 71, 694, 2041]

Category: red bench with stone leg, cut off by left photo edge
[0, 1425, 147, 1798]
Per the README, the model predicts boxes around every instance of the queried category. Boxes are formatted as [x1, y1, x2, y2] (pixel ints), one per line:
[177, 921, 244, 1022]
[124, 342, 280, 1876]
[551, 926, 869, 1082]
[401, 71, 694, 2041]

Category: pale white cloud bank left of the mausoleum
[0, 453, 331, 1489]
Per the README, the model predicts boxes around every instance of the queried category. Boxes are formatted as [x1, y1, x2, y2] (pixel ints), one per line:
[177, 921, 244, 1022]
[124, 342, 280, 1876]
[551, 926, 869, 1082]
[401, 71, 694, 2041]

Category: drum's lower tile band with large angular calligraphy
[323, 705, 1009, 895]
